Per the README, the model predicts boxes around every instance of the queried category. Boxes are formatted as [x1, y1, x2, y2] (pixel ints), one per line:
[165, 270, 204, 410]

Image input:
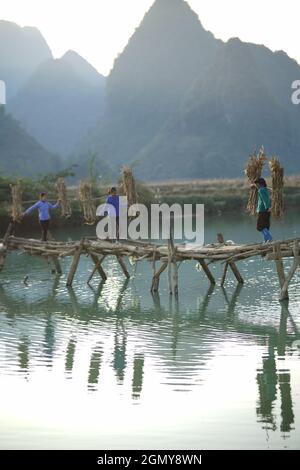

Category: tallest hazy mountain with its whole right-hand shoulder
[74, 0, 300, 179]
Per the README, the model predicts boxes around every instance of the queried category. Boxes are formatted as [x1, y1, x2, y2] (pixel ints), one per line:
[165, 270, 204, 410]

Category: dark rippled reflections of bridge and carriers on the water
[0, 281, 300, 435]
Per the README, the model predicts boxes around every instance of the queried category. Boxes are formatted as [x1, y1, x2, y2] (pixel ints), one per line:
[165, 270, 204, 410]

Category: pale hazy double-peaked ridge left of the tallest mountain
[0, 21, 105, 162]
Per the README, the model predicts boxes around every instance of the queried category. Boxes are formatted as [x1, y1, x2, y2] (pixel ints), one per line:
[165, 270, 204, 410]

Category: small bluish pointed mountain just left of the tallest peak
[7, 53, 105, 157]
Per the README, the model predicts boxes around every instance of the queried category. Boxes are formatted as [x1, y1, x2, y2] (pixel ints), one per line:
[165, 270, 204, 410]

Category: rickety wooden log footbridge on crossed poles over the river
[0, 235, 300, 300]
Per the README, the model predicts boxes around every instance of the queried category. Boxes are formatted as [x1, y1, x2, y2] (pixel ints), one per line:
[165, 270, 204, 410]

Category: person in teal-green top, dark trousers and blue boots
[255, 178, 273, 243]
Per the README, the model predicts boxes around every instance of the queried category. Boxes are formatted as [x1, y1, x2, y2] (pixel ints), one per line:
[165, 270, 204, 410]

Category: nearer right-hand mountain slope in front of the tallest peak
[136, 39, 300, 179]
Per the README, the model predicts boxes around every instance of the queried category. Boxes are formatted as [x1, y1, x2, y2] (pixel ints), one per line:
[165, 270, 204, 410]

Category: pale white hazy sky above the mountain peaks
[0, 0, 300, 75]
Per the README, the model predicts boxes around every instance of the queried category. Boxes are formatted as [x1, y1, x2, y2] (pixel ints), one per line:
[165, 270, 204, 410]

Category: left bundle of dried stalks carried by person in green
[245, 147, 267, 215]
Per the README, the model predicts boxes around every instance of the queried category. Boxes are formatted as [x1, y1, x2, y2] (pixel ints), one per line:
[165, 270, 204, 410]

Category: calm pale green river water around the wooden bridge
[0, 217, 300, 449]
